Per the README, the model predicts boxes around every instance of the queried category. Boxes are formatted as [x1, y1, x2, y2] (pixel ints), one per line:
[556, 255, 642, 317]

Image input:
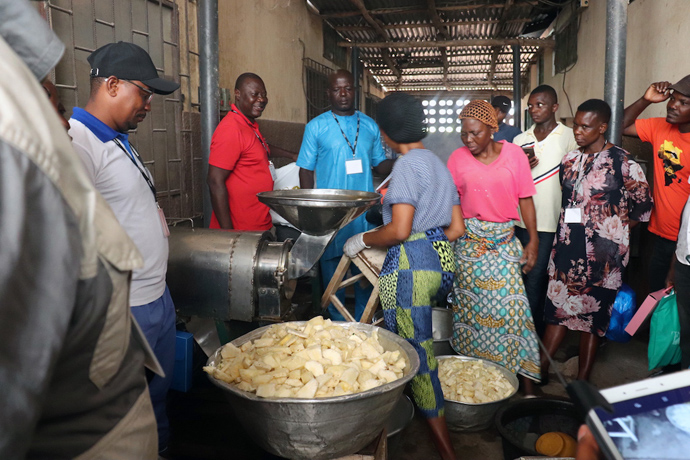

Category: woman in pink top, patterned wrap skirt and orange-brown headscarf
[448, 100, 540, 394]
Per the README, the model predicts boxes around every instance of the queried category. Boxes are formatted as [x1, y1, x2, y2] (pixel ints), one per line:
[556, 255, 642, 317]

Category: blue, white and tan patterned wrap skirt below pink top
[451, 218, 540, 380]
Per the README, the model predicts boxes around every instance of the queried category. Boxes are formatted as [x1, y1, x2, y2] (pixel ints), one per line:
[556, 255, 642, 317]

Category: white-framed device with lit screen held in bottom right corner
[586, 370, 690, 460]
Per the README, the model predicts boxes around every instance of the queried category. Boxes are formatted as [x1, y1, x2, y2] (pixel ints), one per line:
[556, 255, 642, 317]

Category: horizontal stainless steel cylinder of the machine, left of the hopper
[167, 227, 292, 321]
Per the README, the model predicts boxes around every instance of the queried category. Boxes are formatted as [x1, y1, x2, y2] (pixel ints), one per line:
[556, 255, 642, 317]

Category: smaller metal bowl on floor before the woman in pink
[436, 355, 518, 431]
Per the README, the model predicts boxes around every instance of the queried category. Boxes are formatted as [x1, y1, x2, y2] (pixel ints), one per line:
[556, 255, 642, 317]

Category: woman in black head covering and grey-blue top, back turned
[343, 93, 465, 460]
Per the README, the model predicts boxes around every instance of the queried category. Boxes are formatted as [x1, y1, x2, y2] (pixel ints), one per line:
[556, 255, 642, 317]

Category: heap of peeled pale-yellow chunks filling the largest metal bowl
[204, 316, 408, 398]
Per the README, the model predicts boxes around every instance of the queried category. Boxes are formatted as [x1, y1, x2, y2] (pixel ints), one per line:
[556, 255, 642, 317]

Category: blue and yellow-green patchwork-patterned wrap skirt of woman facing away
[379, 227, 455, 418]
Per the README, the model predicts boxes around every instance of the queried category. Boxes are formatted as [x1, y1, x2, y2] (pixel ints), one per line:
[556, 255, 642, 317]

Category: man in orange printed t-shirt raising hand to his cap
[623, 75, 690, 292]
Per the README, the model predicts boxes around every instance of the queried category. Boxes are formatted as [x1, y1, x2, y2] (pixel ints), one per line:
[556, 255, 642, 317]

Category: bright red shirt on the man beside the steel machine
[208, 104, 273, 231]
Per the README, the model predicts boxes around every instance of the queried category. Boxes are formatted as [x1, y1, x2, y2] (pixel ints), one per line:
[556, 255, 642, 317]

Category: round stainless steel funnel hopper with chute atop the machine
[257, 189, 381, 279]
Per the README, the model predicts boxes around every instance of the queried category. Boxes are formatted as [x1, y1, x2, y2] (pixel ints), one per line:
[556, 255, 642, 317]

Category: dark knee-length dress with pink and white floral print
[545, 146, 652, 336]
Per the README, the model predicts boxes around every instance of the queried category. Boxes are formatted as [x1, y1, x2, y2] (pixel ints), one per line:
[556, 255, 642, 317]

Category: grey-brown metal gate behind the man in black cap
[40, 0, 203, 218]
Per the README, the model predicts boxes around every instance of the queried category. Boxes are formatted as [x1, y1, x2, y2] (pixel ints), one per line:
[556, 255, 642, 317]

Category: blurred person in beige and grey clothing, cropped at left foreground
[0, 0, 158, 460]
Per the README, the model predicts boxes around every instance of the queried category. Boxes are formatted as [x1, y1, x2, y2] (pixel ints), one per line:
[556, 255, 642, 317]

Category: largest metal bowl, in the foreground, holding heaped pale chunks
[207, 322, 419, 460]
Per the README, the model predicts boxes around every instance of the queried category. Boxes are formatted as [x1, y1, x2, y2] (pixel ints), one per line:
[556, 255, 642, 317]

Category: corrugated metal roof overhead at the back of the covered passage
[306, 0, 571, 95]
